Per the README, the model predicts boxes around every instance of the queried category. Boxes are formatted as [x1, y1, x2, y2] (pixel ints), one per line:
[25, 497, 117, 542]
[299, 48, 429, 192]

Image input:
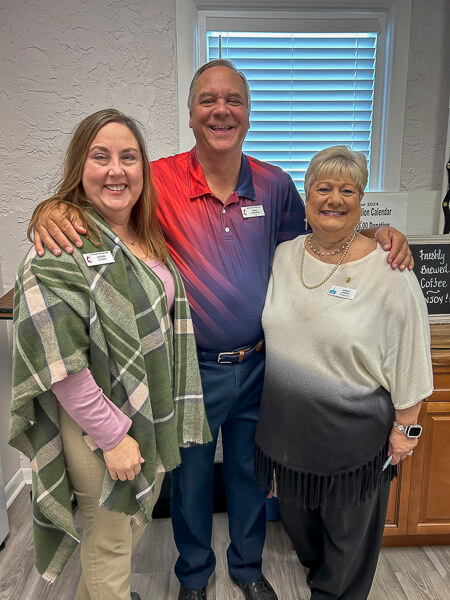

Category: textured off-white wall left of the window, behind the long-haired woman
[0, 0, 178, 287]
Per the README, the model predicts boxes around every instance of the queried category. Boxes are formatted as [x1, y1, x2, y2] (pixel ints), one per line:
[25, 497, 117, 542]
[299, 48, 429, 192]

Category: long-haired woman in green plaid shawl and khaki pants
[10, 109, 211, 600]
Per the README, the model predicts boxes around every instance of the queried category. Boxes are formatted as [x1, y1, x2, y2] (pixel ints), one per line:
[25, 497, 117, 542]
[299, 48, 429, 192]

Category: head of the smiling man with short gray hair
[189, 66, 250, 159]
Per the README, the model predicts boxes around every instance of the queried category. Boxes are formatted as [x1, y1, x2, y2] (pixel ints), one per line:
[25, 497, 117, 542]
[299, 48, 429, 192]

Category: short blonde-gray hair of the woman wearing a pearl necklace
[305, 146, 369, 199]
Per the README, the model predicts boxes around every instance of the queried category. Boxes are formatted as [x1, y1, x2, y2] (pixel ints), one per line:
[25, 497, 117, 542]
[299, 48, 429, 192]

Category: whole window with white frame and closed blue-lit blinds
[177, 0, 411, 191]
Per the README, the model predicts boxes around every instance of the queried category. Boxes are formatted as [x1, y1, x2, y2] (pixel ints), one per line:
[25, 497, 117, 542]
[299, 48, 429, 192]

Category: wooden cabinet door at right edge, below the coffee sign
[407, 404, 450, 535]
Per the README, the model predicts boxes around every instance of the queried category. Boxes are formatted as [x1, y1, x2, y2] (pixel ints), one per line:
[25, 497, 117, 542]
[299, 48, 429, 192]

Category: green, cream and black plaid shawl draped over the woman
[10, 214, 211, 581]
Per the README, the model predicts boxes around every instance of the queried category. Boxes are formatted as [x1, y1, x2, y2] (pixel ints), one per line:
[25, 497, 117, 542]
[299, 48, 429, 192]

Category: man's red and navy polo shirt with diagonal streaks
[151, 148, 305, 351]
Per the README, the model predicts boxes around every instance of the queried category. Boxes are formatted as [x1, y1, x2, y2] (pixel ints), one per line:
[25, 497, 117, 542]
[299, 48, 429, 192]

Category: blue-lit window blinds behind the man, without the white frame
[206, 31, 377, 191]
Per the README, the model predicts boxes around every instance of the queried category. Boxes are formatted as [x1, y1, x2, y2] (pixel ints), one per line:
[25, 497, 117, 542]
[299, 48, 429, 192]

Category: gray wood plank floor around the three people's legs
[0, 488, 450, 600]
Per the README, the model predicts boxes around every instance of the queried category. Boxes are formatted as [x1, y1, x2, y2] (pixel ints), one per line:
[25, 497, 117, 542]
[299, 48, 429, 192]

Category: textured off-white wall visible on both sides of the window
[0, 0, 450, 492]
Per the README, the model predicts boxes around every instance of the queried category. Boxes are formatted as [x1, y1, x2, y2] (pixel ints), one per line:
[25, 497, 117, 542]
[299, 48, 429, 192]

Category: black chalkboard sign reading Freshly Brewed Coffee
[408, 235, 450, 323]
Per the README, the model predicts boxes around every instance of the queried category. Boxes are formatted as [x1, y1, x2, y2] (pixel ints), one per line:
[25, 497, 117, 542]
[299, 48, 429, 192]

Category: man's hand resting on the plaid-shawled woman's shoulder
[33, 201, 86, 256]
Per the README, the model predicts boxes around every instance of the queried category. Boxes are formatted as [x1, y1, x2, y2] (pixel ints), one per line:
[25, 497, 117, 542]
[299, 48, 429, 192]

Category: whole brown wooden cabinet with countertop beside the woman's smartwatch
[383, 324, 450, 546]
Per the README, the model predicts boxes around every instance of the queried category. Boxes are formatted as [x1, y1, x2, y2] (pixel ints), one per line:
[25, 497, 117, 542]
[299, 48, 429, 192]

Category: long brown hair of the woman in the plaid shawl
[27, 108, 167, 261]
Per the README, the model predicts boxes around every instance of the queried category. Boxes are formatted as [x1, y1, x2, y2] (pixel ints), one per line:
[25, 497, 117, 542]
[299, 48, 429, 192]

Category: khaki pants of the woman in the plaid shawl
[59, 407, 164, 600]
